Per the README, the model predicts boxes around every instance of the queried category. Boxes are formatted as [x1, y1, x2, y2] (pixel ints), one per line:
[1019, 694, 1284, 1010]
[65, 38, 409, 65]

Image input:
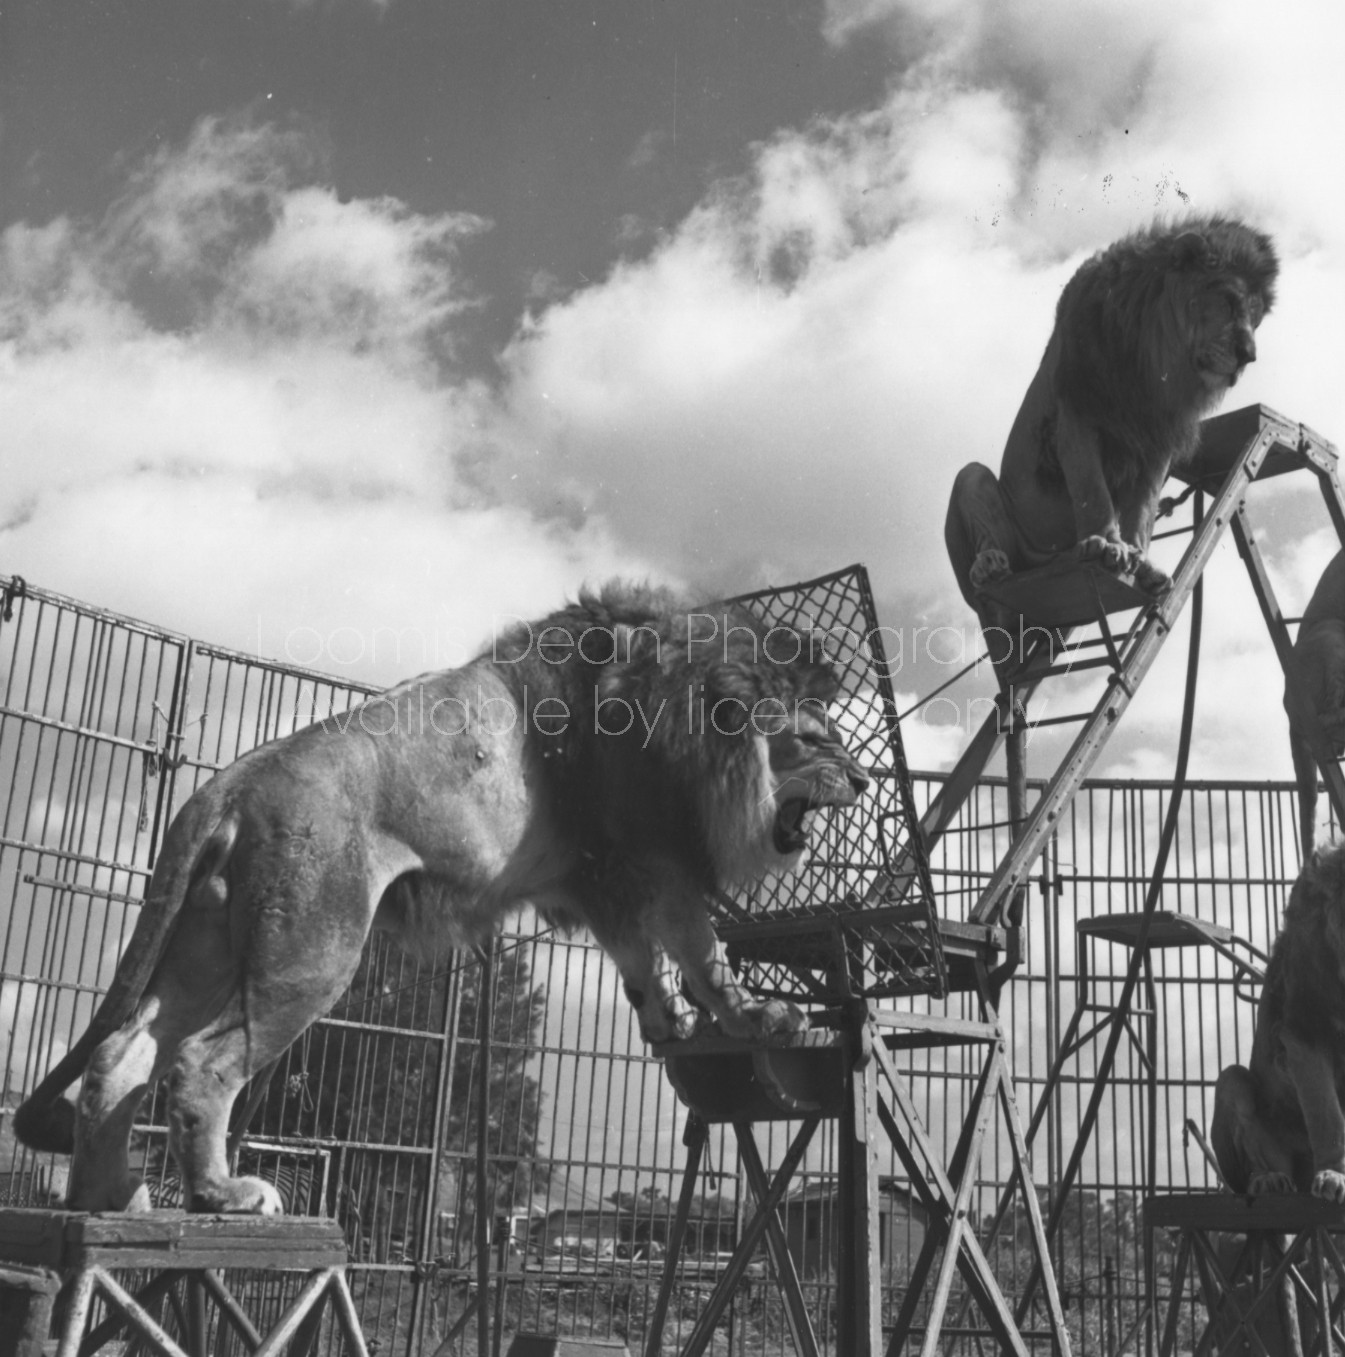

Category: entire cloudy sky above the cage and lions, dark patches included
[0, 0, 1345, 776]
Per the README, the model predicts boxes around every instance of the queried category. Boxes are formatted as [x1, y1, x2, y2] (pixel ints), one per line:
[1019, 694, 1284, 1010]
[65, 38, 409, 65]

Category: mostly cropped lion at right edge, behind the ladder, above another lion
[1284, 551, 1345, 862]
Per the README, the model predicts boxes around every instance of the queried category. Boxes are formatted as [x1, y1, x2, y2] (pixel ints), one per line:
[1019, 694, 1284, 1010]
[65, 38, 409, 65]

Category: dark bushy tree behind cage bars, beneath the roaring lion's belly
[248, 938, 550, 1259]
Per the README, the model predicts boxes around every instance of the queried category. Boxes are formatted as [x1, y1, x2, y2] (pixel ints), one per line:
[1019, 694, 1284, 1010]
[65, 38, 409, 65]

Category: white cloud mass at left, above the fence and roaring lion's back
[0, 119, 651, 679]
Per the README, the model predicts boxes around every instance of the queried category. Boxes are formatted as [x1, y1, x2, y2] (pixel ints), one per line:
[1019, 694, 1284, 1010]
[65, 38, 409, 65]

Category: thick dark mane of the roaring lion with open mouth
[493, 582, 836, 890]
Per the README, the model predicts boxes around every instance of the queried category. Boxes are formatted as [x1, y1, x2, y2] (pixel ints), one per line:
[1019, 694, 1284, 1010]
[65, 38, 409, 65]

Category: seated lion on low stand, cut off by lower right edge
[1209, 844, 1345, 1202]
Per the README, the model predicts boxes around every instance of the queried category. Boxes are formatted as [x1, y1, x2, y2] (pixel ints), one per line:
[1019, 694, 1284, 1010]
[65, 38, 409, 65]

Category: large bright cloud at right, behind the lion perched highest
[483, 0, 1345, 776]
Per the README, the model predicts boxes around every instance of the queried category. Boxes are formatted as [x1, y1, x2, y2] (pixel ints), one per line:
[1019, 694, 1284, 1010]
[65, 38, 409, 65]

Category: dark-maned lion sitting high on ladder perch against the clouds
[945, 216, 1278, 665]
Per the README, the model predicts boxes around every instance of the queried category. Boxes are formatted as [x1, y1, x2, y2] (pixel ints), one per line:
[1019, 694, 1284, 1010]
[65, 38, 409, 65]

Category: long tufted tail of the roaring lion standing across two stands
[14, 814, 238, 1155]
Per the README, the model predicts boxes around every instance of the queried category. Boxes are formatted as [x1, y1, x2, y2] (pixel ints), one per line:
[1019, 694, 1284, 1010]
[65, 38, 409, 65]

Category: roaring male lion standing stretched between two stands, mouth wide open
[15, 585, 867, 1213]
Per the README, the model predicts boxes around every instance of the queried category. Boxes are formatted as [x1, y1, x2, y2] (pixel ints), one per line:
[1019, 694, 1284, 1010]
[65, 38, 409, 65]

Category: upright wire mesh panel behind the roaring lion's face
[718, 566, 947, 1003]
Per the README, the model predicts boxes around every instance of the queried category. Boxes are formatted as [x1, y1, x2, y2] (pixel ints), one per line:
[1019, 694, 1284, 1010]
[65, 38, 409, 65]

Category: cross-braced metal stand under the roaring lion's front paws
[645, 924, 1071, 1357]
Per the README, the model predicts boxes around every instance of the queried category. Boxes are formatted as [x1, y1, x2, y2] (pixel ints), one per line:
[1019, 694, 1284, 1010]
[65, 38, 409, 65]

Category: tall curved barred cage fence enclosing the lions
[0, 573, 1324, 1357]
